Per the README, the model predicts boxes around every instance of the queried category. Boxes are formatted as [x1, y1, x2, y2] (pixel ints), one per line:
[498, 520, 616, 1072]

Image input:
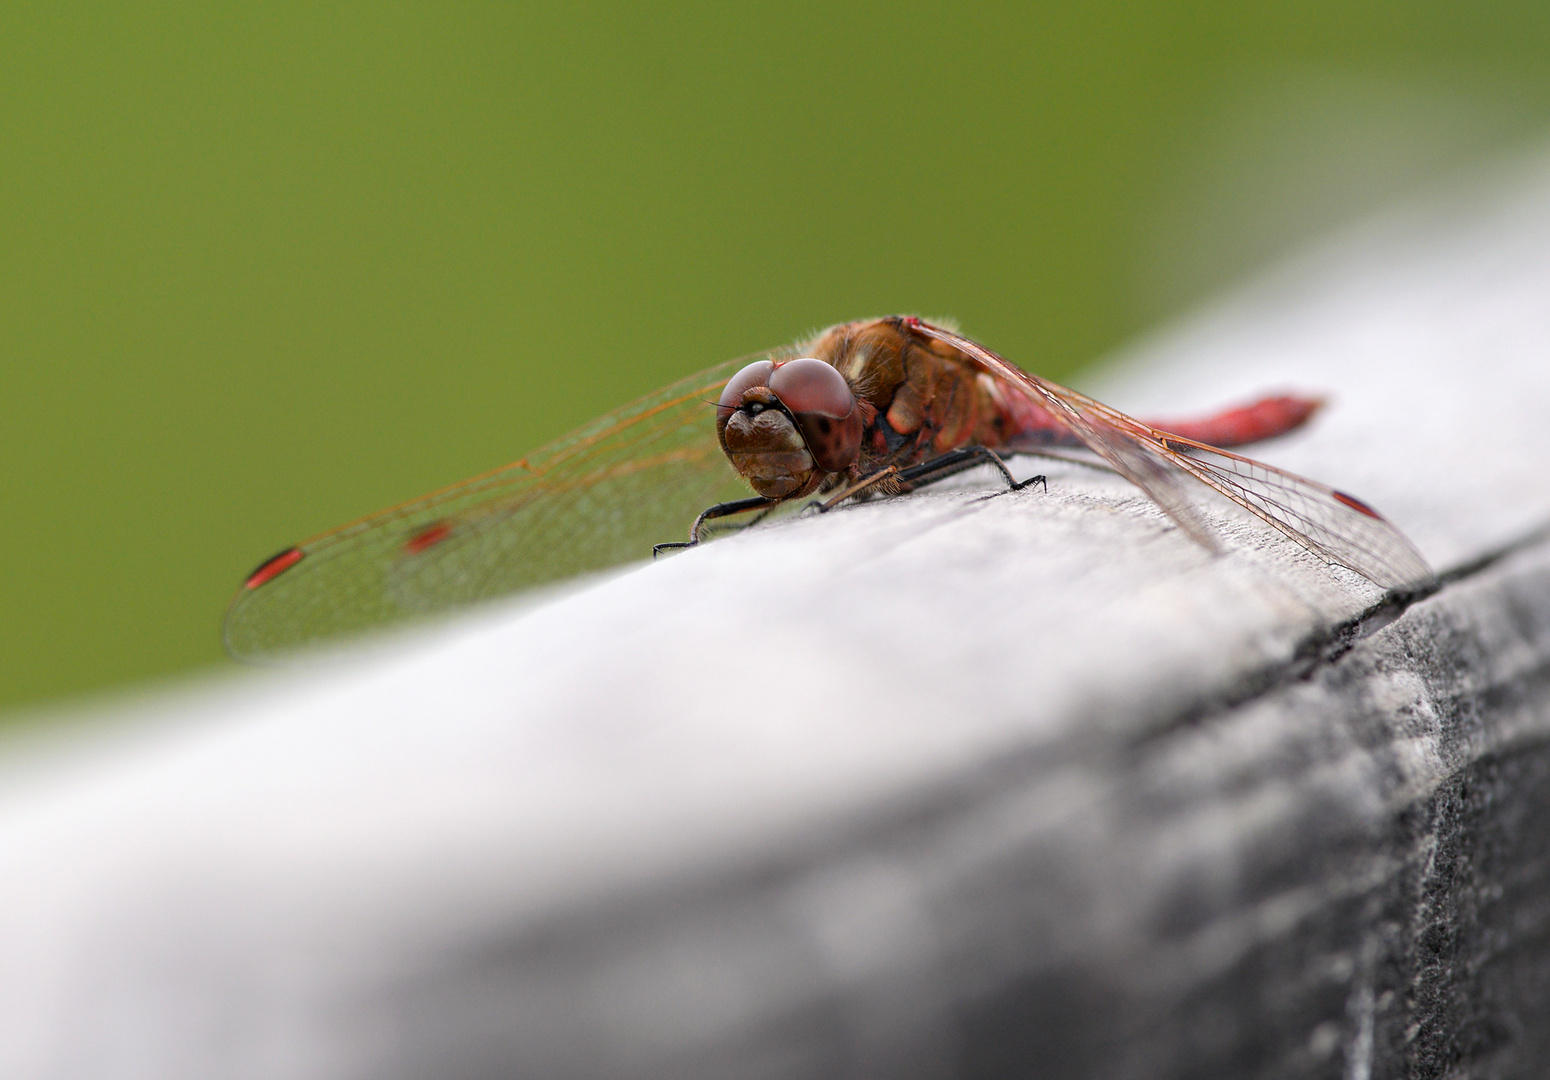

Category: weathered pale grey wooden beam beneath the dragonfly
[0, 151, 1550, 1080]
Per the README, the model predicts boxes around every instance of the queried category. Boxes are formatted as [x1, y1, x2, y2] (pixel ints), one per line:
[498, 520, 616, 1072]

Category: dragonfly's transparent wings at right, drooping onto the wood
[911, 321, 1432, 589]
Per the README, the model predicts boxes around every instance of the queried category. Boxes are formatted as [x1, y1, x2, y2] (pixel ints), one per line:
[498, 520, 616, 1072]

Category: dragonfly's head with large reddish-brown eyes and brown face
[716, 356, 862, 499]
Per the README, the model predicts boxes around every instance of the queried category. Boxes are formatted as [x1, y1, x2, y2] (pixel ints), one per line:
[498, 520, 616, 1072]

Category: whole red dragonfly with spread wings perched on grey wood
[225, 316, 1432, 657]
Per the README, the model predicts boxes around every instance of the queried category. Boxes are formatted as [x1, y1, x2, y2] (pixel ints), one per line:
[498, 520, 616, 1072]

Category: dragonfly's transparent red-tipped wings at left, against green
[225, 353, 764, 657]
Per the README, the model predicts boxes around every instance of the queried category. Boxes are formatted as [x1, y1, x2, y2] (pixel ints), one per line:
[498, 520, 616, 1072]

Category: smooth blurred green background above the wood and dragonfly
[0, 0, 1550, 707]
